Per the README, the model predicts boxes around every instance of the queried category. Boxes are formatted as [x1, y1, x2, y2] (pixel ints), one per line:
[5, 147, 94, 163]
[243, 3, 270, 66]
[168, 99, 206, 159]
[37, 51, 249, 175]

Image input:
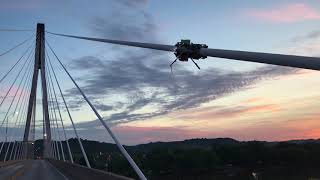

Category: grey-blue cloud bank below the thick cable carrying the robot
[68, 53, 295, 123]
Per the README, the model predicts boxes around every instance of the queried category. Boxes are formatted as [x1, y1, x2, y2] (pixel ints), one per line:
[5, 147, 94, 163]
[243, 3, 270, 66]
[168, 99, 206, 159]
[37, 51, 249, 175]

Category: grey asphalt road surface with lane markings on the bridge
[0, 160, 67, 180]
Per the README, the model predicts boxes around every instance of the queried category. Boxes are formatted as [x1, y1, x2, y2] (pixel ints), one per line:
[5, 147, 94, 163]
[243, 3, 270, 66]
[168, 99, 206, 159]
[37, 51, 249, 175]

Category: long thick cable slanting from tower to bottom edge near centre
[47, 42, 147, 180]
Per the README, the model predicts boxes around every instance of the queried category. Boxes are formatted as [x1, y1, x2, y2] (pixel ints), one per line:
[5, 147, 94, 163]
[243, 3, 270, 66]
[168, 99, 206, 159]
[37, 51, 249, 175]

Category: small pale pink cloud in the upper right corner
[247, 3, 320, 23]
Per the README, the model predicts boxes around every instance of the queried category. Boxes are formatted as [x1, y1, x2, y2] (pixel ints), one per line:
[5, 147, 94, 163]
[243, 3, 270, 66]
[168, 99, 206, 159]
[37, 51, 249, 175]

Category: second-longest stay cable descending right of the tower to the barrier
[48, 51, 91, 168]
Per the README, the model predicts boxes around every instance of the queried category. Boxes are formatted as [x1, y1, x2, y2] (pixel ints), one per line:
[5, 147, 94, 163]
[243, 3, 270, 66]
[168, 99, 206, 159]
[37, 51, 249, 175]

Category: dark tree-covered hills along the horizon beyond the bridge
[35, 138, 320, 180]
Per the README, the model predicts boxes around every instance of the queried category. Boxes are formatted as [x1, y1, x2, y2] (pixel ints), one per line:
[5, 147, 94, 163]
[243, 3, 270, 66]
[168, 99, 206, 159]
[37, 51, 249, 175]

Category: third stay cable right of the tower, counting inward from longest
[46, 51, 73, 163]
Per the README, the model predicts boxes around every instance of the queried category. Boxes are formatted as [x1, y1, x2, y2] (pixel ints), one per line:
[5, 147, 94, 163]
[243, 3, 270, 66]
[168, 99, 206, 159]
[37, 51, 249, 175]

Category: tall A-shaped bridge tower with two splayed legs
[23, 23, 51, 159]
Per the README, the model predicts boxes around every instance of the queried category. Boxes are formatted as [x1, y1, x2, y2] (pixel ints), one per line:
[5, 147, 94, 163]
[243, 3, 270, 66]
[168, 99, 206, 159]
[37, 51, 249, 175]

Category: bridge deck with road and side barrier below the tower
[0, 160, 132, 180]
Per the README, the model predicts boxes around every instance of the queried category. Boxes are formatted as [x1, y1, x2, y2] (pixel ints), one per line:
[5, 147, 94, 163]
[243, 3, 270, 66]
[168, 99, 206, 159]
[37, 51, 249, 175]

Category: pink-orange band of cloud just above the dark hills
[113, 114, 320, 144]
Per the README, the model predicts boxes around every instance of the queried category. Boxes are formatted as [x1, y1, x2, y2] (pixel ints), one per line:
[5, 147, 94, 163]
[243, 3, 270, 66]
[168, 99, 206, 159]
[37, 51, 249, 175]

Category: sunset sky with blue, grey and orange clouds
[0, 0, 320, 145]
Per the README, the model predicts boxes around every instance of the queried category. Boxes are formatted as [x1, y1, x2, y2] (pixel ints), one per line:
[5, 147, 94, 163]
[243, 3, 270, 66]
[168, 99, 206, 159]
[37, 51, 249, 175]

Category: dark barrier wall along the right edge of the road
[48, 159, 133, 180]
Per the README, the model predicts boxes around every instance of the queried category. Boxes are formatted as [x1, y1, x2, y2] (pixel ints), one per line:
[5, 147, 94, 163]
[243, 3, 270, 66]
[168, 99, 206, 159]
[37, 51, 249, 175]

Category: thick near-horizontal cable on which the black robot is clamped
[47, 32, 320, 71]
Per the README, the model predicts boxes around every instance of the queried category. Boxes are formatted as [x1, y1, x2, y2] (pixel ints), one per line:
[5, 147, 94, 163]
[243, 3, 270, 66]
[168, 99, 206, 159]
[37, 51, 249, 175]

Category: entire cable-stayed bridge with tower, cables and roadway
[0, 24, 320, 180]
